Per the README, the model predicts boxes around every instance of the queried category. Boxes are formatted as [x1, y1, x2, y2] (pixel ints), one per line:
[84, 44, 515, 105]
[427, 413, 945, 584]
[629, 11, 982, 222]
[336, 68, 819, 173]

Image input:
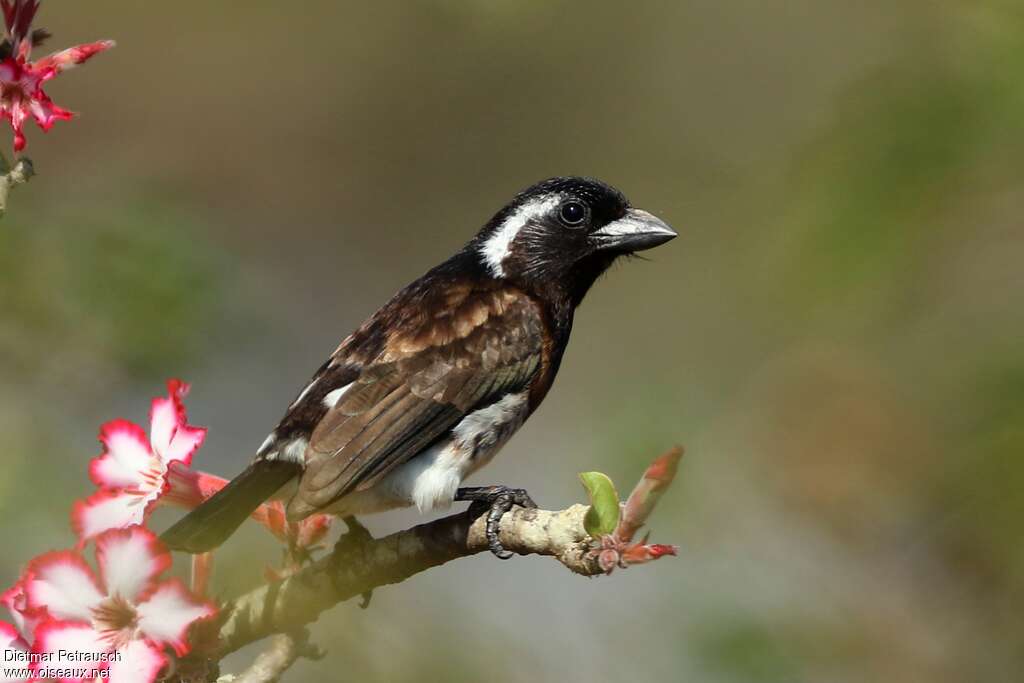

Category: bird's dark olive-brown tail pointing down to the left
[160, 460, 298, 554]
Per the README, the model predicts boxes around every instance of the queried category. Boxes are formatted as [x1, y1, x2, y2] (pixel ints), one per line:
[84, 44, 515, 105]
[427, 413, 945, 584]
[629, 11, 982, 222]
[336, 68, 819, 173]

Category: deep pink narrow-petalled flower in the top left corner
[0, 0, 114, 152]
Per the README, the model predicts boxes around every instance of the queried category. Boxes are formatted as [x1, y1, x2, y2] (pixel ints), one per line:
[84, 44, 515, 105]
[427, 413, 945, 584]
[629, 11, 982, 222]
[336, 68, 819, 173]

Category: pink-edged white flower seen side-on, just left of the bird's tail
[72, 380, 206, 543]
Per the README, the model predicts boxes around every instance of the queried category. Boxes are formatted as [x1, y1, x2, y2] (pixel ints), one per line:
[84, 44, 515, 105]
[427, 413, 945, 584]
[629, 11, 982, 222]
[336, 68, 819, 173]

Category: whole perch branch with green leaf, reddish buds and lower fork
[173, 446, 683, 683]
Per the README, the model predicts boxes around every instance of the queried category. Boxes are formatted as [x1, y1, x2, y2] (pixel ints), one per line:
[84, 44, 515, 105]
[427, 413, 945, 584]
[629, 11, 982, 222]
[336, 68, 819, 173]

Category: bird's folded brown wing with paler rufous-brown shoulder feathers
[289, 287, 543, 516]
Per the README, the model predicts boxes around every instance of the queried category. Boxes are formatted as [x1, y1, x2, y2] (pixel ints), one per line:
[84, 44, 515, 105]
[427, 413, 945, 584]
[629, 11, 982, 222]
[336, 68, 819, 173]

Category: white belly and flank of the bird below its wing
[327, 393, 527, 516]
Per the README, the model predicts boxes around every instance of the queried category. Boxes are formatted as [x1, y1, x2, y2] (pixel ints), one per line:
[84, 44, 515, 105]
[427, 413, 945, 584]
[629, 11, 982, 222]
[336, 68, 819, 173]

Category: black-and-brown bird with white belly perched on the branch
[162, 176, 677, 559]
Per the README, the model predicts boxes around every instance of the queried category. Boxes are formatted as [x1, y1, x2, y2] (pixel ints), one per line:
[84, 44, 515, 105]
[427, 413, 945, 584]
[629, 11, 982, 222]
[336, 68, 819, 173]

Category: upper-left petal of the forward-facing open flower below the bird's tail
[25, 550, 104, 622]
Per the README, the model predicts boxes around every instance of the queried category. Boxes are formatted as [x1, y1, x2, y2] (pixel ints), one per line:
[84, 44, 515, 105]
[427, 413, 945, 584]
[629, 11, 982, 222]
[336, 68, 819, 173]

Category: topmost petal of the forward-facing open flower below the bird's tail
[96, 526, 171, 602]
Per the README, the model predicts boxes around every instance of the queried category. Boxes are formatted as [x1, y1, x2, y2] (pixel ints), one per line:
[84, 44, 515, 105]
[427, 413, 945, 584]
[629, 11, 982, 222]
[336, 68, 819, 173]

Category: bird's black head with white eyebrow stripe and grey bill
[469, 177, 676, 305]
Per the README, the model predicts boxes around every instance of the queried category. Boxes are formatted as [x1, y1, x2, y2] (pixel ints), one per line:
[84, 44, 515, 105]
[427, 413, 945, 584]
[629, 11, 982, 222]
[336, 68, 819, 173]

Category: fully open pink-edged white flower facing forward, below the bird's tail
[24, 526, 216, 683]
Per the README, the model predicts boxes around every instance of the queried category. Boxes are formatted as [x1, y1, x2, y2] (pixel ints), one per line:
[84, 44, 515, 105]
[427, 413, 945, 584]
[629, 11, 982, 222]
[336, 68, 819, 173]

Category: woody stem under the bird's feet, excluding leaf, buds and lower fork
[216, 505, 603, 659]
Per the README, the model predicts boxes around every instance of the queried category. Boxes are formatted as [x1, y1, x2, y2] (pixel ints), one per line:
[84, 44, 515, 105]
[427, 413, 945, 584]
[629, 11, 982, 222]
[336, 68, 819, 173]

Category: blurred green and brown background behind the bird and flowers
[0, 0, 1024, 683]
